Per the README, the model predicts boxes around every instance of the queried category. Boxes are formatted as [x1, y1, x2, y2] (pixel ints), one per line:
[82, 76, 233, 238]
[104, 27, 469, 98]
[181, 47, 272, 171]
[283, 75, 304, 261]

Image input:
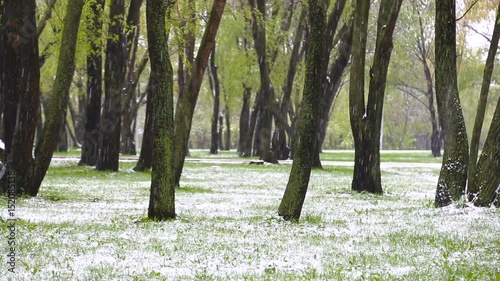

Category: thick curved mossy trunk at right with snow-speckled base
[435, 0, 469, 207]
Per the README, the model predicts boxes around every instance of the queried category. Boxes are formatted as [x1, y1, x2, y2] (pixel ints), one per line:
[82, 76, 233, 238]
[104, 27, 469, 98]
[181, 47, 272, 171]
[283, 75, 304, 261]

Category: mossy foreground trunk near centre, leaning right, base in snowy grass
[278, 0, 327, 220]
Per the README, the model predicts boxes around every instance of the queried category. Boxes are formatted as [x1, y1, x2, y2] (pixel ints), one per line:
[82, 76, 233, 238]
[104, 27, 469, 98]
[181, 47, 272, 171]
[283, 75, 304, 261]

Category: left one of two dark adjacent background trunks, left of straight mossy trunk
[78, 0, 105, 166]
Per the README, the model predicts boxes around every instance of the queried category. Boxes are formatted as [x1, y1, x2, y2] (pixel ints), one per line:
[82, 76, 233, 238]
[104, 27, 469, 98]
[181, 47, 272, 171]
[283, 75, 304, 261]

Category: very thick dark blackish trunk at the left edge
[0, 0, 40, 192]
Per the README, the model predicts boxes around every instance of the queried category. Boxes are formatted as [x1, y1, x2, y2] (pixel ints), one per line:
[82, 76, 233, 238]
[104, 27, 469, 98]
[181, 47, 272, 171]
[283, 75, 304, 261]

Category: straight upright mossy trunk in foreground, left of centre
[146, 0, 176, 220]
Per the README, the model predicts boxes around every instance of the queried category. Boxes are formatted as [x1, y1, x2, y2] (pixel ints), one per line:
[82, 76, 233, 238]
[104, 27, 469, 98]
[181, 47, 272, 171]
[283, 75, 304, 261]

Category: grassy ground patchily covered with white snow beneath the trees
[0, 151, 500, 280]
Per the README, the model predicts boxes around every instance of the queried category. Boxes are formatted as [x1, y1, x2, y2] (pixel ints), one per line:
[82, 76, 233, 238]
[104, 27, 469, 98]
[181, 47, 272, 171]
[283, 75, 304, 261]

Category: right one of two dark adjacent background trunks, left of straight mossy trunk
[96, 0, 127, 171]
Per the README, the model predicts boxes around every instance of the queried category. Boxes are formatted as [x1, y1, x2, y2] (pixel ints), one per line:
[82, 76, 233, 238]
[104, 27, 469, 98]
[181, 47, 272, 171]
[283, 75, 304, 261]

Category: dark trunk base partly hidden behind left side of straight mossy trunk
[134, 82, 154, 172]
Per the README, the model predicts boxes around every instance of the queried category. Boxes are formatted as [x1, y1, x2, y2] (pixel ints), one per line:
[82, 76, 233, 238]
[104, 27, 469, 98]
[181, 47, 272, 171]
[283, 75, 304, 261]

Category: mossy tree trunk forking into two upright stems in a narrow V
[349, 0, 402, 193]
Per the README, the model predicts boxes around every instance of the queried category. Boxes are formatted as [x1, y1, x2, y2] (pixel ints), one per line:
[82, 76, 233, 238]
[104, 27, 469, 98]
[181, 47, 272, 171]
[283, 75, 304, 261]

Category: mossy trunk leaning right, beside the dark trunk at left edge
[28, 0, 84, 196]
